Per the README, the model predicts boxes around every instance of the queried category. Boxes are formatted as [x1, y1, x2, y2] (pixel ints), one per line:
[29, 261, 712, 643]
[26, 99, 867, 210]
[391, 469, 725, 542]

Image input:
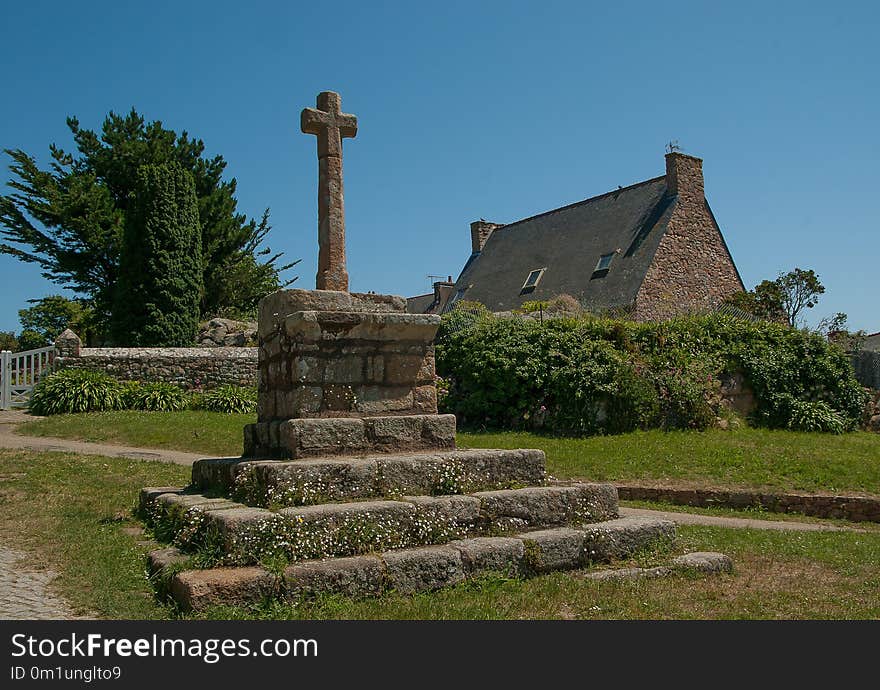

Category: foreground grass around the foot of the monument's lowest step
[0, 450, 880, 619]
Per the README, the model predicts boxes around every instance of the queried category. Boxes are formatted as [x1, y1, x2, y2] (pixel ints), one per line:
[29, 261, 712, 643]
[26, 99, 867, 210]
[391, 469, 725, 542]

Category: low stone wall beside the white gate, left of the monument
[54, 347, 257, 390]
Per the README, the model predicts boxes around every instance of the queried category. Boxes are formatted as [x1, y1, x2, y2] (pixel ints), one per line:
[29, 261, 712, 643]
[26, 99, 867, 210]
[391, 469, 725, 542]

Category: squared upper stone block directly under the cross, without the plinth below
[257, 290, 440, 422]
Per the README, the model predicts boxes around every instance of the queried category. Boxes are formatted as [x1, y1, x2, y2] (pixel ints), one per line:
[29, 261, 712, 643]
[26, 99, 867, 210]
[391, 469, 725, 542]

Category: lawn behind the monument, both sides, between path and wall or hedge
[18, 412, 880, 494]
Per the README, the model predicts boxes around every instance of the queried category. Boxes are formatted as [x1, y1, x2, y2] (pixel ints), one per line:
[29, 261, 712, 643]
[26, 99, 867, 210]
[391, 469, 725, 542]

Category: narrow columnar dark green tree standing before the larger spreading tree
[111, 163, 203, 347]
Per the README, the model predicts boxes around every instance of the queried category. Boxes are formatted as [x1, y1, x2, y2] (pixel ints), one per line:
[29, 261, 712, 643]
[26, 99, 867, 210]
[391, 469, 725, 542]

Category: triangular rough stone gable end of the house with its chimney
[634, 153, 744, 321]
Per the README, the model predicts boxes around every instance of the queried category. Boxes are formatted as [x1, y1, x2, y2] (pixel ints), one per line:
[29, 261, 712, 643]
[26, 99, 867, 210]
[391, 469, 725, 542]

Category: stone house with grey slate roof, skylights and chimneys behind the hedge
[407, 152, 744, 320]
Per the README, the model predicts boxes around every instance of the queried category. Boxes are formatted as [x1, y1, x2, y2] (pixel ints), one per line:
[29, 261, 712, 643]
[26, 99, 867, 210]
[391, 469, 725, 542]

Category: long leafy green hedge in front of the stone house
[437, 313, 865, 434]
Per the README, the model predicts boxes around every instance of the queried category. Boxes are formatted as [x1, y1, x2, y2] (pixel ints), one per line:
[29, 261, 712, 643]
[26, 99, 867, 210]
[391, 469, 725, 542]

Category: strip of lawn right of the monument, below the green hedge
[458, 428, 880, 494]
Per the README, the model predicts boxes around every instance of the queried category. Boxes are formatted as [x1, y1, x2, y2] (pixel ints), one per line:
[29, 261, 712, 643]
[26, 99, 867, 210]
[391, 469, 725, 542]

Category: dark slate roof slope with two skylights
[455, 175, 673, 311]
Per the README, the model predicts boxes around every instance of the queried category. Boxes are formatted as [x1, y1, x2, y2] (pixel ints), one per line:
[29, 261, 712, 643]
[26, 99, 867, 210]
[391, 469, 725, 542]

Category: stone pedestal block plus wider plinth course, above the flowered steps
[245, 290, 446, 458]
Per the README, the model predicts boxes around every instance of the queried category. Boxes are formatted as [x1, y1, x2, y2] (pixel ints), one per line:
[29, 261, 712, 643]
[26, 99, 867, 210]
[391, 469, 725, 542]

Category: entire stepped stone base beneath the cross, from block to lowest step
[140, 290, 675, 610]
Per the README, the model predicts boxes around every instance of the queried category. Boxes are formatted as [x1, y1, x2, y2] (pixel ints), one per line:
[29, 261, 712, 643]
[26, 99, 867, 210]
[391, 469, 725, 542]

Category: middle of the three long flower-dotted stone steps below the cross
[145, 484, 617, 565]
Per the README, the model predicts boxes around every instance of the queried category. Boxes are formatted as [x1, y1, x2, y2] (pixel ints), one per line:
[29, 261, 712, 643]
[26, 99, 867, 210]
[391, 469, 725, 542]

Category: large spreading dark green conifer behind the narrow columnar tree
[0, 110, 296, 338]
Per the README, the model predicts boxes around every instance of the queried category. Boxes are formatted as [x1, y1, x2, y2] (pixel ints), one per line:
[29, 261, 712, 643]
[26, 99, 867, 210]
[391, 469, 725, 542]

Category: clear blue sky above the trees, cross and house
[0, 0, 880, 332]
